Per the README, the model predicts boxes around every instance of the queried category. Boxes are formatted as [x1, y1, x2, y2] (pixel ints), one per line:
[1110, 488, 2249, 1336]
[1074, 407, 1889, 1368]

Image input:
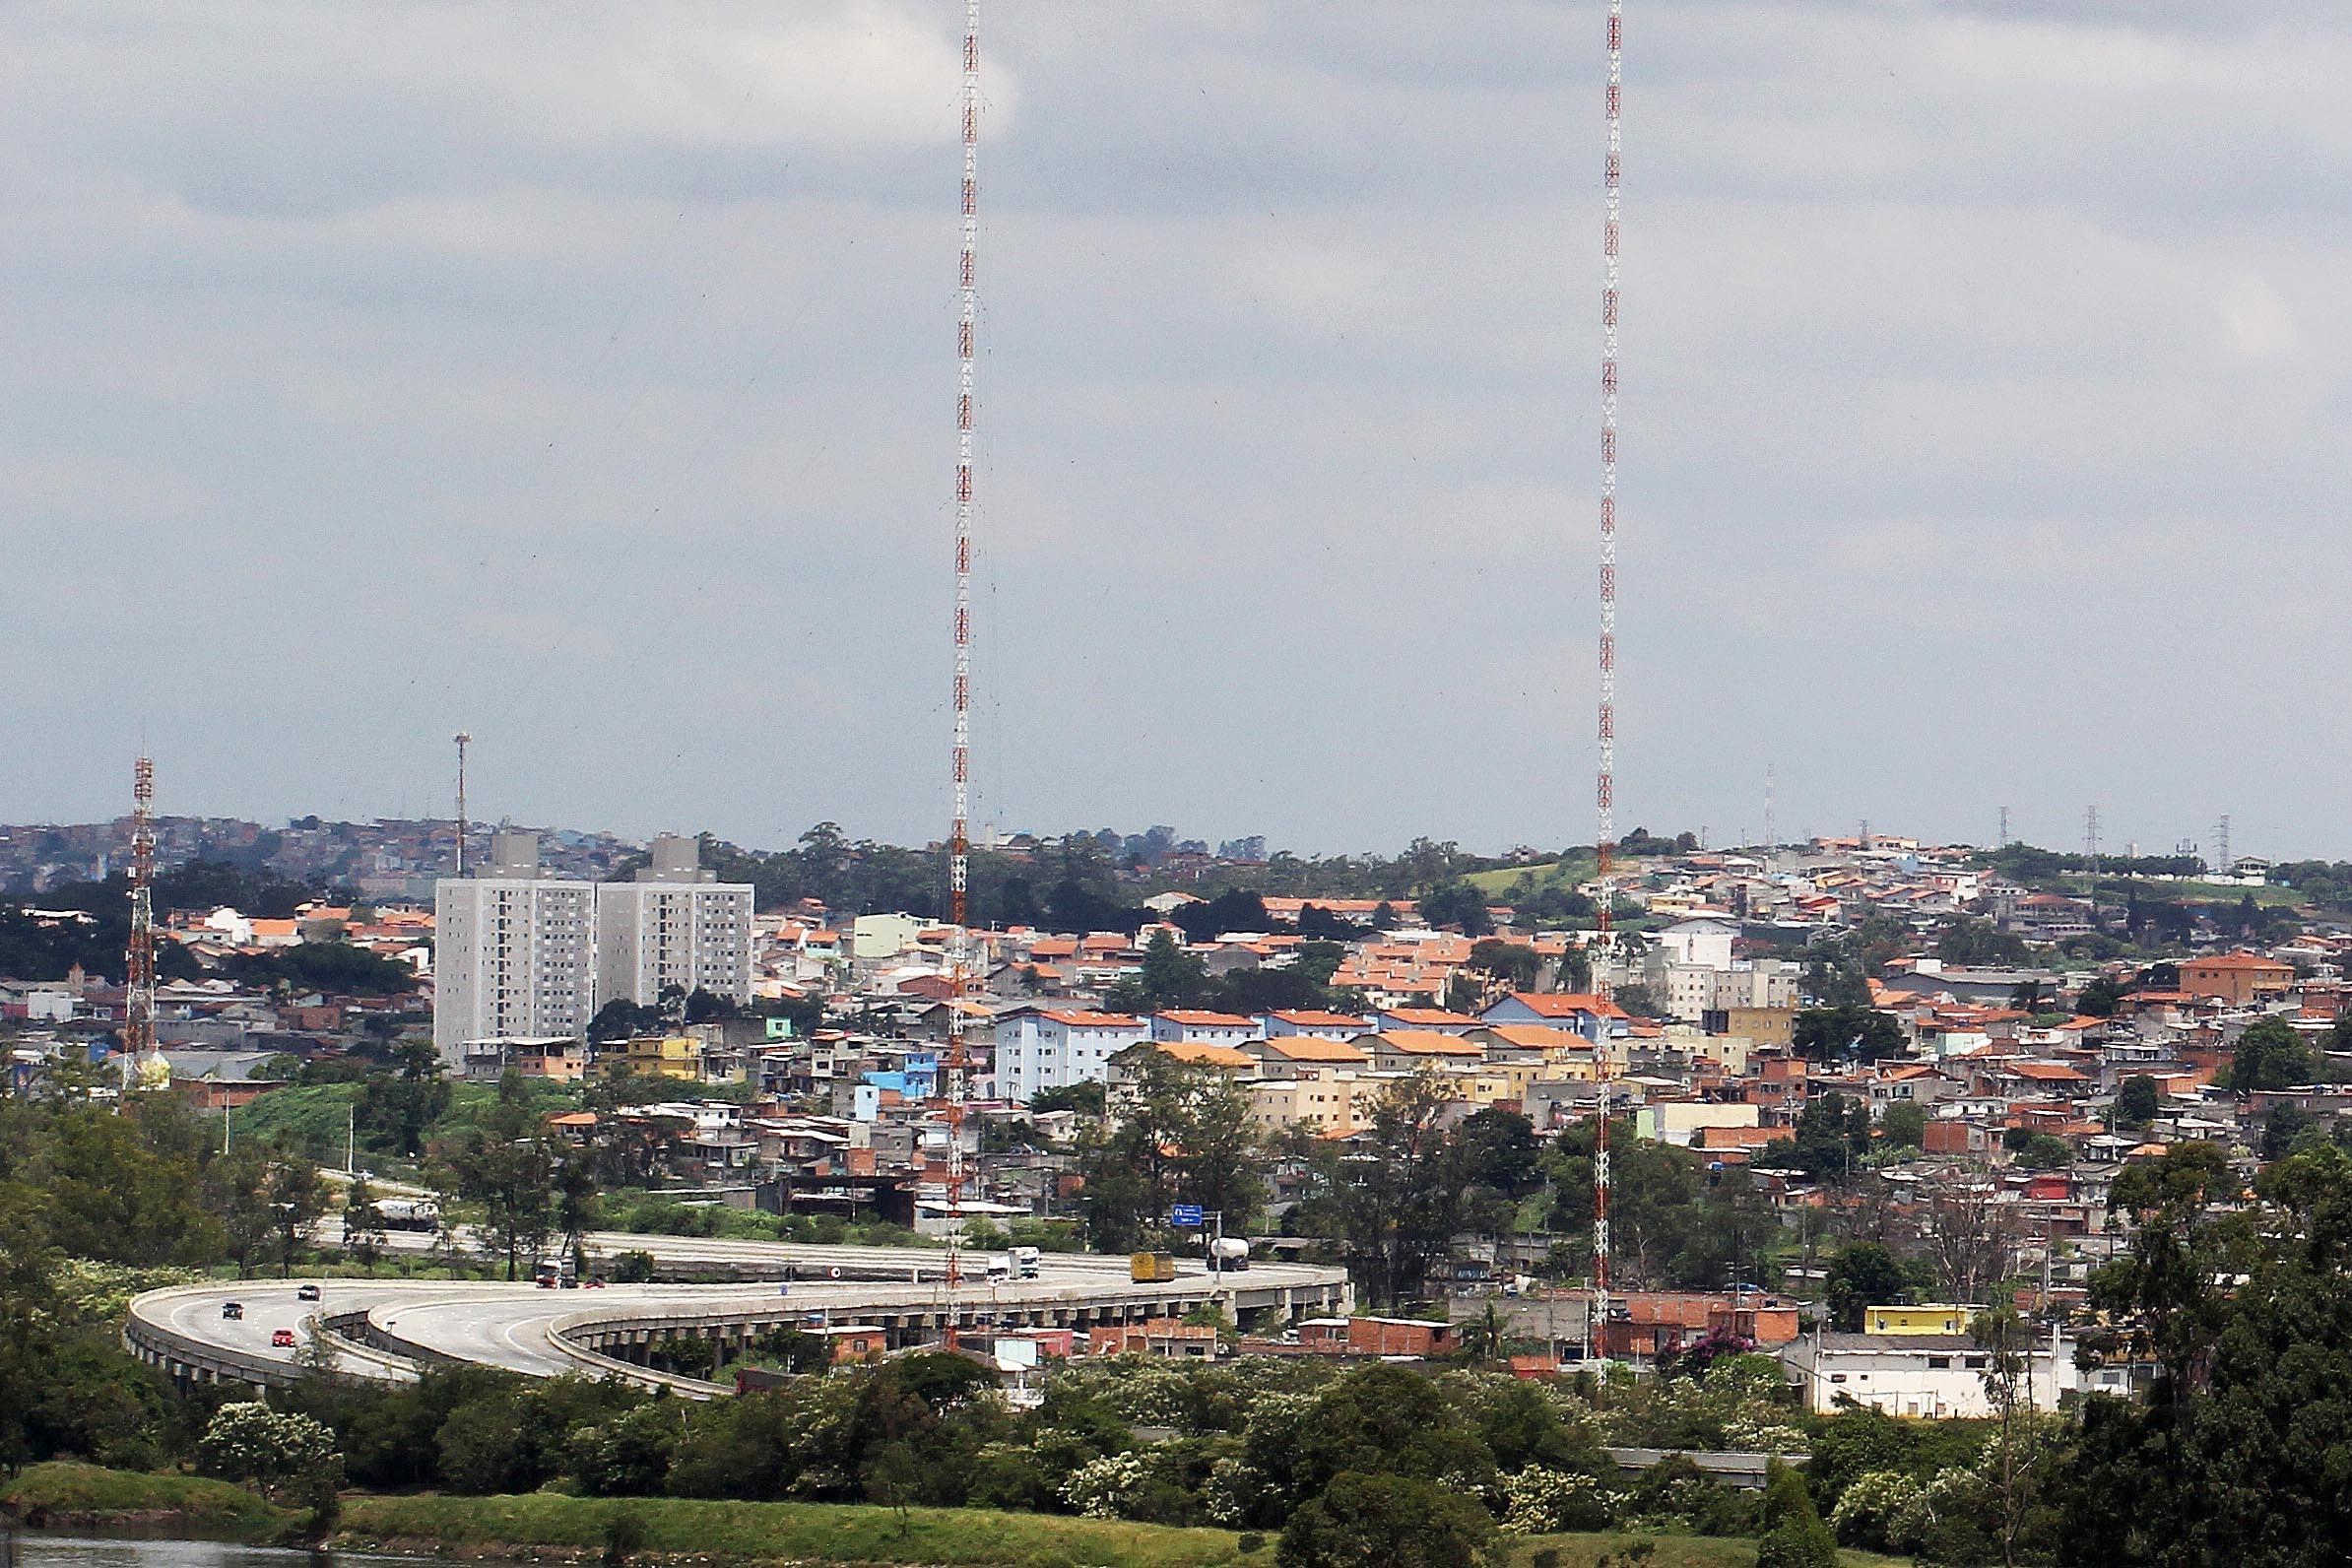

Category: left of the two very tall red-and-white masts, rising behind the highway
[941, 0, 981, 1349]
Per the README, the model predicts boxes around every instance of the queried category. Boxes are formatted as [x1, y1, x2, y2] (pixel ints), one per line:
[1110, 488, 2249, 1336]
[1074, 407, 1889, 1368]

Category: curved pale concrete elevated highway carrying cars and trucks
[122, 1232, 1350, 1397]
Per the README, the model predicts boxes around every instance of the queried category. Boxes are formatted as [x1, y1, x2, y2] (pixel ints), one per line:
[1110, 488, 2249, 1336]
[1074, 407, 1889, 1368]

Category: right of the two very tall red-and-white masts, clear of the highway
[1586, 0, 1625, 1351]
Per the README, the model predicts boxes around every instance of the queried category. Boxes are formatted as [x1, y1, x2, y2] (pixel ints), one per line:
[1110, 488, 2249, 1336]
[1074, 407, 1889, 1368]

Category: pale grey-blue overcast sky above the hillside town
[0, 0, 2352, 856]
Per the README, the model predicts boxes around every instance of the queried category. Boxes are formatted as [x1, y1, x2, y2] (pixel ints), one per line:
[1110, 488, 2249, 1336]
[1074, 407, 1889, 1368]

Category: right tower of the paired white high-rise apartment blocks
[595, 834, 752, 1007]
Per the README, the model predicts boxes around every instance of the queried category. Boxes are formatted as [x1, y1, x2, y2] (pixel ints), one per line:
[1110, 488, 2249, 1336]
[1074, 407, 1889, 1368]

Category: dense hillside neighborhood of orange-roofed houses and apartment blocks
[0, 832, 2352, 1415]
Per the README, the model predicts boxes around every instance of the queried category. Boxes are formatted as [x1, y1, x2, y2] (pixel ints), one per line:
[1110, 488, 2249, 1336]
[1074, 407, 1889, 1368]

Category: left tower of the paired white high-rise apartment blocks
[432, 832, 598, 1070]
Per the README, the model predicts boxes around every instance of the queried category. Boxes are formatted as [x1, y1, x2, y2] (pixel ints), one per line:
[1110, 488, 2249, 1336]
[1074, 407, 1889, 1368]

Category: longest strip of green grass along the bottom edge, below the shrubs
[339, 1493, 1273, 1568]
